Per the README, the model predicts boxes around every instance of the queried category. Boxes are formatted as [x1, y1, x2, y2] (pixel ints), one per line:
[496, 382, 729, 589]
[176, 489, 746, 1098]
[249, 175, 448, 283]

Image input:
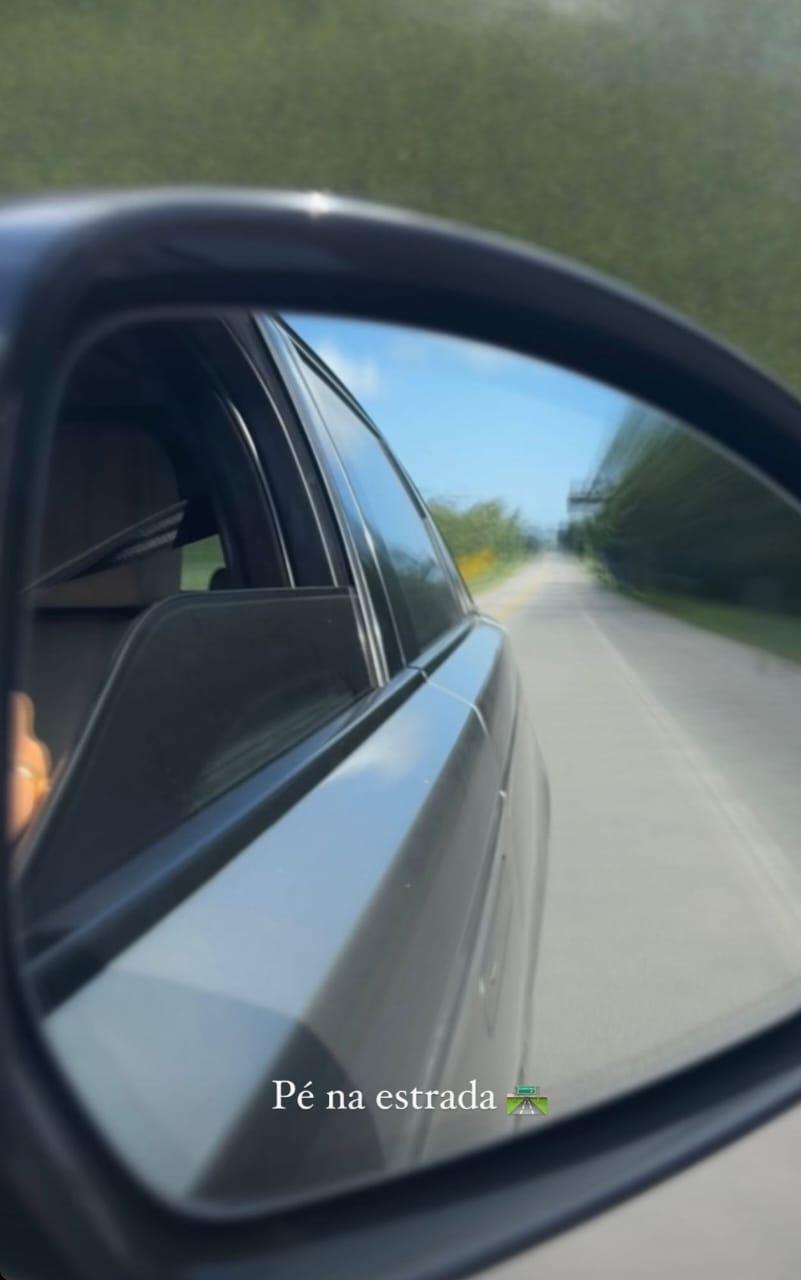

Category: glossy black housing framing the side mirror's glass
[0, 191, 801, 1280]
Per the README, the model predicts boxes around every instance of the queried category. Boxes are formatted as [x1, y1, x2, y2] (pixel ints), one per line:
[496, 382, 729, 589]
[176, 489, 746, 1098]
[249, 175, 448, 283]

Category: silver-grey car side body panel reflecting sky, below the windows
[42, 663, 500, 1199]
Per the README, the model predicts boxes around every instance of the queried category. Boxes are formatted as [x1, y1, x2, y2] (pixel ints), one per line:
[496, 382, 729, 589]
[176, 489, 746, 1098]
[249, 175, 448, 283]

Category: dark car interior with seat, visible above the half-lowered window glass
[24, 325, 238, 767]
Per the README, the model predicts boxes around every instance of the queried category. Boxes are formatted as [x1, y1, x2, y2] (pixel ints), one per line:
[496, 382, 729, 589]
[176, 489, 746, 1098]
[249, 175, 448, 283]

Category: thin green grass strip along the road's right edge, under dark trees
[618, 588, 801, 663]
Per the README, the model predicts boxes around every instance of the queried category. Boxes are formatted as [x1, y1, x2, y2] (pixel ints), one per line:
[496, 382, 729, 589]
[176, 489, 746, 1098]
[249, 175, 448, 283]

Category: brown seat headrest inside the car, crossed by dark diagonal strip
[36, 422, 180, 609]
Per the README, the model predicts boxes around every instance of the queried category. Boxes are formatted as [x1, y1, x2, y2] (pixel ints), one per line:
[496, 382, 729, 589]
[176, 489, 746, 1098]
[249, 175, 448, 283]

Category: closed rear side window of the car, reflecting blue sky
[299, 362, 462, 659]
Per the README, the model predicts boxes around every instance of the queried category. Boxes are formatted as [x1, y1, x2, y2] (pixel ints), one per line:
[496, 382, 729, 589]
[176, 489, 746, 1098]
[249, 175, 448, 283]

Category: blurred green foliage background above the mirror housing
[0, 0, 801, 387]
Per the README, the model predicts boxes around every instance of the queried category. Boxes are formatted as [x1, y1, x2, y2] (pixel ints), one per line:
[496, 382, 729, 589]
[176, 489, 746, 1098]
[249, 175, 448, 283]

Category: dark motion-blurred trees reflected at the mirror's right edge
[562, 408, 801, 613]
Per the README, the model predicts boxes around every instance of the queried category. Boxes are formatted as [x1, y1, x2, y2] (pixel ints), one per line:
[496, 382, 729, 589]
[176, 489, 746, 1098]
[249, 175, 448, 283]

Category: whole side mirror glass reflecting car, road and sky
[10, 315, 801, 1211]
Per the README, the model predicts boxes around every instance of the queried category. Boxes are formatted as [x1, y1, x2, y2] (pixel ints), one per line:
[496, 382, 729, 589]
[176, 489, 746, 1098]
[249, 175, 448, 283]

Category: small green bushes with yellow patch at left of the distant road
[429, 498, 539, 590]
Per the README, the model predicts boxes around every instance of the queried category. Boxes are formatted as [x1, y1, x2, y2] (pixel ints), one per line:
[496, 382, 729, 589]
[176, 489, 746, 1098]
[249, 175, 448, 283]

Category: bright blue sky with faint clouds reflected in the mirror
[287, 315, 628, 529]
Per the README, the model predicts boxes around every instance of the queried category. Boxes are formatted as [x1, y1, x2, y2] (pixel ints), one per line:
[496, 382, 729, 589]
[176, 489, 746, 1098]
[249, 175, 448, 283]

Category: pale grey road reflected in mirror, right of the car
[480, 553, 801, 1115]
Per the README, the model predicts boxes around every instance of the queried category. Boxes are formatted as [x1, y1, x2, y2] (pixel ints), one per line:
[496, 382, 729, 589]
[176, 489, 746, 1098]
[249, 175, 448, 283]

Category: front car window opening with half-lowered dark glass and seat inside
[19, 318, 369, 914]
